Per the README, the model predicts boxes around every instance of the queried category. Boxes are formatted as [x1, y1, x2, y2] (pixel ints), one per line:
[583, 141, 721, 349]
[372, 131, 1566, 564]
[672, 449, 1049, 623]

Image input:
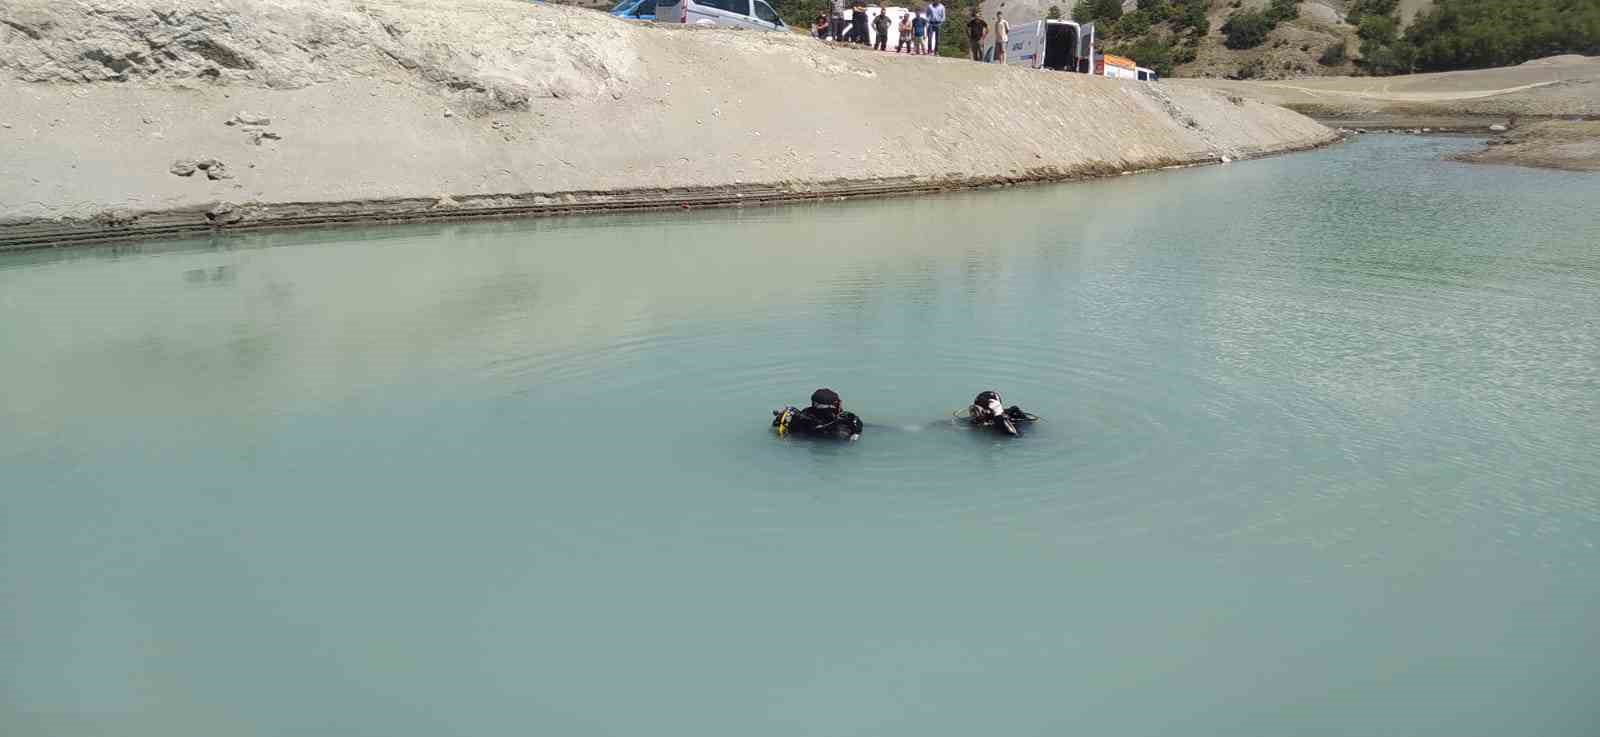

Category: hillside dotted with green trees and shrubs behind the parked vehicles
[566, 0, 1600, 80]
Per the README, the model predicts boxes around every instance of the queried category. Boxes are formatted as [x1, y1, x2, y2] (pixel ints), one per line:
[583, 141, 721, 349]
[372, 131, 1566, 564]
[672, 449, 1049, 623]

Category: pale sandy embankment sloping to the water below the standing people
[0, 0, 1338, 246]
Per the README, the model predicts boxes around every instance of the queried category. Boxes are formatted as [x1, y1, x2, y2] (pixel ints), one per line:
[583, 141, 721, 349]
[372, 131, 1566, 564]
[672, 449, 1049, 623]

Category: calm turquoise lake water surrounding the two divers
[9, 136, 1600, 737]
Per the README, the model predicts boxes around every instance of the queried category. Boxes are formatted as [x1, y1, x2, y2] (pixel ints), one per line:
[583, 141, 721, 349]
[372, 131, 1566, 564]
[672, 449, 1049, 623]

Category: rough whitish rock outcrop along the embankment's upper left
[0, 0, 638, 109]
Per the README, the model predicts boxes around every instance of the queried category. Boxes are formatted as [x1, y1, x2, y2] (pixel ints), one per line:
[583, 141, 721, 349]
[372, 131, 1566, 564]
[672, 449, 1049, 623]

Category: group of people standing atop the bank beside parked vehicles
[811, 0, 1011, 64]
